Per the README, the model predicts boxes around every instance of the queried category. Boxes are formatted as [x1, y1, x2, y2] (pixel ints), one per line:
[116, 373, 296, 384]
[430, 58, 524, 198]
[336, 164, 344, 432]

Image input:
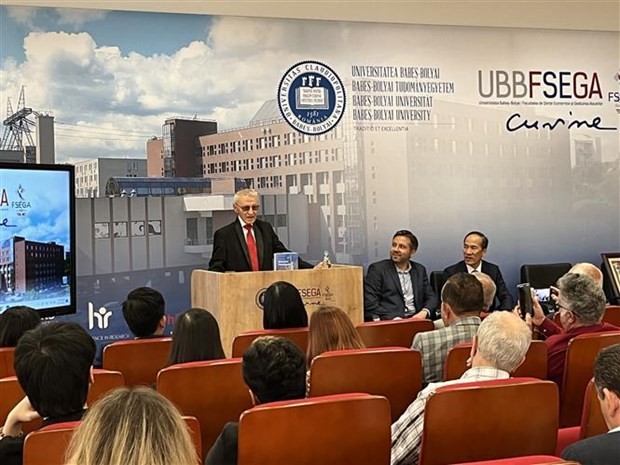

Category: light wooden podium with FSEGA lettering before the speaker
[191, 265, 364, 357]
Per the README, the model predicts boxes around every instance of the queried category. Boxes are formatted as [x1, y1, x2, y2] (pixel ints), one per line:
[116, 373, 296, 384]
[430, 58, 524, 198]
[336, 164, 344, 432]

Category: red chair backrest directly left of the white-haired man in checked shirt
[308, 347, 422, 422]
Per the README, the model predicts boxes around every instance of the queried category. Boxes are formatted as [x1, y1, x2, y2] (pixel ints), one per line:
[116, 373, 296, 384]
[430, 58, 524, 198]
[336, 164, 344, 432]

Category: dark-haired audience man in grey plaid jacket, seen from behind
[411, 273, 484, 383]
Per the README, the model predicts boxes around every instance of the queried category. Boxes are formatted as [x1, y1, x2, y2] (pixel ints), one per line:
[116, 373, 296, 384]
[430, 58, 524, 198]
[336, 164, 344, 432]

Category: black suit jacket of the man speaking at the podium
[209, 218, 312, 272]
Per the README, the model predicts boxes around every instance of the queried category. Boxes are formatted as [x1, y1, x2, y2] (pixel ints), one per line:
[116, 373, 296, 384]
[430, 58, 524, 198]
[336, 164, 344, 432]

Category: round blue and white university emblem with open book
[278, 61, 345, 135]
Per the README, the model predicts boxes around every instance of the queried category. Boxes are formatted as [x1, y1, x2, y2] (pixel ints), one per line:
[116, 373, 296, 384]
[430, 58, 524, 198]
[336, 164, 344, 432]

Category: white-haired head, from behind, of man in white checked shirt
[472, 312, 532, 373]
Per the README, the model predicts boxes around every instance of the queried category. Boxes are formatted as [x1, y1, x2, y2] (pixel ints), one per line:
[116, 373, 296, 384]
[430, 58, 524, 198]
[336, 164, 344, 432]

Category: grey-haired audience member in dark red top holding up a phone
[526, 273, 620, 387]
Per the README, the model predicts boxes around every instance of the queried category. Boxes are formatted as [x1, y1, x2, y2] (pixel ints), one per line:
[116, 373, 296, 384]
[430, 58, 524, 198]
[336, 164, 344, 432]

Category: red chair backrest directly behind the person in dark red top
[560, 332, 620, 428]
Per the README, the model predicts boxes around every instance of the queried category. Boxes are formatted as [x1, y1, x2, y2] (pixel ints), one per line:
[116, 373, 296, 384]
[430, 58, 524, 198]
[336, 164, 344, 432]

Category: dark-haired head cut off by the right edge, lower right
[594, 344, 620, 429]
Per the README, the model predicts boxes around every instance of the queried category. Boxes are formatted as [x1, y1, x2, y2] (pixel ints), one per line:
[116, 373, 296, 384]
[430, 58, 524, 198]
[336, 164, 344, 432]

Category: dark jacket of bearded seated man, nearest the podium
[364, 259, 439, 320]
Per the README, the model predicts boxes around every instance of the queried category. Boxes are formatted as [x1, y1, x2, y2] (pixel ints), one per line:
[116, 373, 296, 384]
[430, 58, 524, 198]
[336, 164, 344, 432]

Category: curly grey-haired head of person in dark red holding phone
[555, 273, 606, 331]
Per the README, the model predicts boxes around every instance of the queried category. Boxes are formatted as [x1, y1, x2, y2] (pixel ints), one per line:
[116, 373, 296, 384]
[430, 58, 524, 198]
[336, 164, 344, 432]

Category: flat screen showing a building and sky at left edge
[0, 163, 76, 317]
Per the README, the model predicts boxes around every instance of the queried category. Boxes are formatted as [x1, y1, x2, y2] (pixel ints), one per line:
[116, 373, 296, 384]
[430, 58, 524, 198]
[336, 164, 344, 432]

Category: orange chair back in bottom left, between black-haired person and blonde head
[23, 421, 79, 465]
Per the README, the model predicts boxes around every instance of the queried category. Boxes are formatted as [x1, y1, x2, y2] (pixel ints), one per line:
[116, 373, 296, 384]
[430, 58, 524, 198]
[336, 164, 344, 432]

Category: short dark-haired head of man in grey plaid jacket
[441, 273, 484, 326]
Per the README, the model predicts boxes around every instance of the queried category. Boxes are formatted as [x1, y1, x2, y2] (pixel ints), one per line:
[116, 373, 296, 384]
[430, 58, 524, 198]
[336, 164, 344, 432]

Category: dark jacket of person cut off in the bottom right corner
[562, 431, 620, 465]
